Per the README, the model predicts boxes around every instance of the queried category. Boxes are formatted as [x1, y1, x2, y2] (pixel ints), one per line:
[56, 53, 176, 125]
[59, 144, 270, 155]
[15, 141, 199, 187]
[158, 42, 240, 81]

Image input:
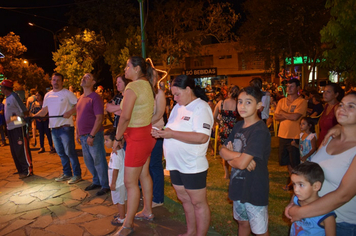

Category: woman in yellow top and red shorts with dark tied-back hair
[113, 56, 156, 235]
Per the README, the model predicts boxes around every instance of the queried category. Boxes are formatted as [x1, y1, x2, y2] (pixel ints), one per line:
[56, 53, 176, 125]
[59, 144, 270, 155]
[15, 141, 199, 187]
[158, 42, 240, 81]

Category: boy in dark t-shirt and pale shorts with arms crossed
[220, 87, 271, 235]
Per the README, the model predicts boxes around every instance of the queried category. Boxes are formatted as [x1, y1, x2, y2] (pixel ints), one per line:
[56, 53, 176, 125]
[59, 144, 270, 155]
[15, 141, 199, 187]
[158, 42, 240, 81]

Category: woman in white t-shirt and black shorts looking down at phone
[152, 75, 214, 235]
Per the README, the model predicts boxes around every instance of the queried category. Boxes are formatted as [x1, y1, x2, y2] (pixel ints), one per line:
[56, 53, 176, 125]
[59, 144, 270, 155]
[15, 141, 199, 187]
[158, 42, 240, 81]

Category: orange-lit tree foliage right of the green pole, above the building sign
[147, 0, 239, 70]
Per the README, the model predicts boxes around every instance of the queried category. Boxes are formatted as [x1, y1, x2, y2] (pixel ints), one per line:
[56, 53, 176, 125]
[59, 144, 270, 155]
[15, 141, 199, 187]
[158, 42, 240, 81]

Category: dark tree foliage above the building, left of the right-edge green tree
[239, 0, 330, 83]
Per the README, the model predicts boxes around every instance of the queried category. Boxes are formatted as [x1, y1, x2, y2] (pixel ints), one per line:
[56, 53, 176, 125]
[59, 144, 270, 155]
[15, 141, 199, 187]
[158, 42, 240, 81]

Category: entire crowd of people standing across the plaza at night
[0, 56, 356, 236]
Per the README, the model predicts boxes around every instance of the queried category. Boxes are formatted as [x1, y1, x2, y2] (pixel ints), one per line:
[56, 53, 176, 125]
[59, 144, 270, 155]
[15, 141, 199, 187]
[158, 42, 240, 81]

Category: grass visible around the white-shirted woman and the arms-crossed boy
[164, 137, 291, 236]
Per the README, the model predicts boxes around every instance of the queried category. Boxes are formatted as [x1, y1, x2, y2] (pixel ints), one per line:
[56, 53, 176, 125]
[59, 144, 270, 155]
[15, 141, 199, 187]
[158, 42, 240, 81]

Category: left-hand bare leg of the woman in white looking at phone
[173, 184, 197, 236]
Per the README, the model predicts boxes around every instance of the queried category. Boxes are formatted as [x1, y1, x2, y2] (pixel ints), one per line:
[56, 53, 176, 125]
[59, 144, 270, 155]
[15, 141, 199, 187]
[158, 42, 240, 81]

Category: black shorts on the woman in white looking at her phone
[170, 170, 208, 189]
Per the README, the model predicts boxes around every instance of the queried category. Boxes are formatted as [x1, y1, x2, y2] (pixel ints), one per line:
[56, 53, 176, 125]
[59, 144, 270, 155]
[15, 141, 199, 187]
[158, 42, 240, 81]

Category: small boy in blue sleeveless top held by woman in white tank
[290, 161, 336, 236]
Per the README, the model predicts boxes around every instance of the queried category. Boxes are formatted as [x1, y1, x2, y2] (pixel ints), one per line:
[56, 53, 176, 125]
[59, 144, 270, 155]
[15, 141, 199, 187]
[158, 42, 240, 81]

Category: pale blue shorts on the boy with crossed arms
[233, 201, 268, 234]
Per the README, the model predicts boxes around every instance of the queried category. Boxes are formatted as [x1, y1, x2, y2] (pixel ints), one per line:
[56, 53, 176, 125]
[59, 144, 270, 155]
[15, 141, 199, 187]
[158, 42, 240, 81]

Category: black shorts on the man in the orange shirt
[279, 138, 300, 168]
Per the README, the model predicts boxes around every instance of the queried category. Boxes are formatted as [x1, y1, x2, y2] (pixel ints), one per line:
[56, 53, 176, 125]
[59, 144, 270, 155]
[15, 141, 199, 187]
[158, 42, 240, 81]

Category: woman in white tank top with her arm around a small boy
[286, 92, 356, 236]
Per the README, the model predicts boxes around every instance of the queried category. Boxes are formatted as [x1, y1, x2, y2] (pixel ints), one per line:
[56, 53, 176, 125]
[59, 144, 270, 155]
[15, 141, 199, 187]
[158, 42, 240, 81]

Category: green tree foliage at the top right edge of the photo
[321, 0, 356, 84]
